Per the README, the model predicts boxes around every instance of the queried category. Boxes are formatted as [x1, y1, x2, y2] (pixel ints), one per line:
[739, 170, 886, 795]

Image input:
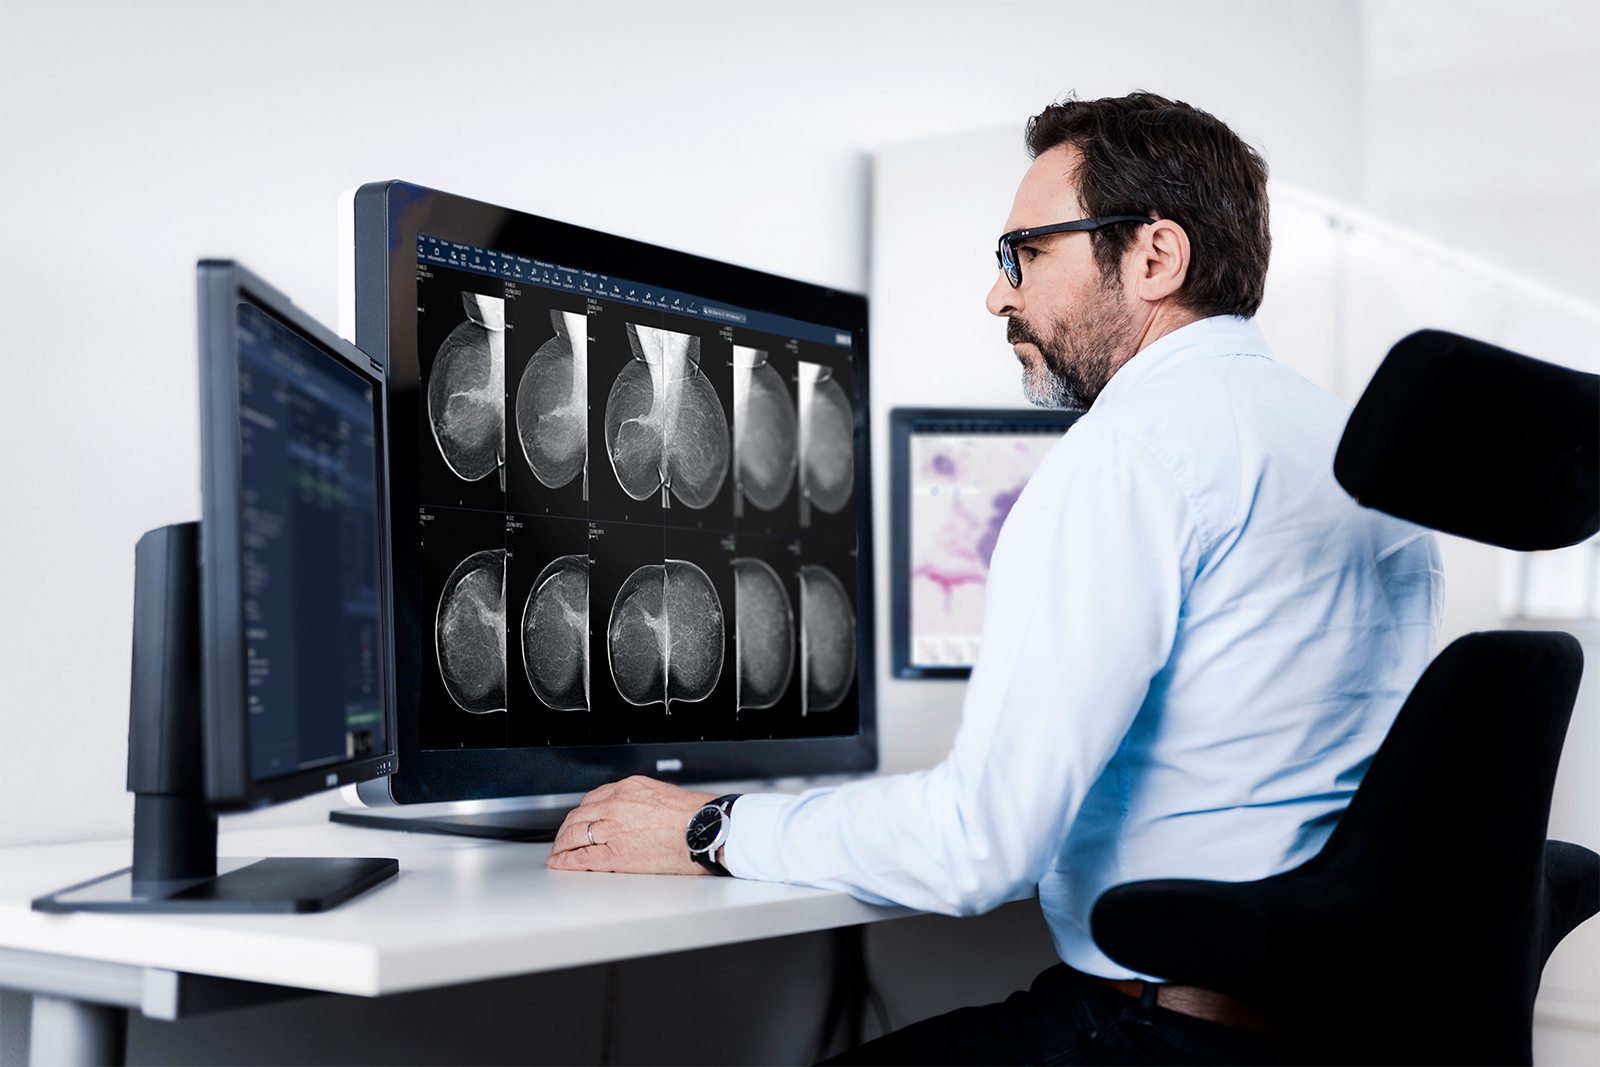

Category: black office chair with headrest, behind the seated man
[1090, 331, 1600, 1064]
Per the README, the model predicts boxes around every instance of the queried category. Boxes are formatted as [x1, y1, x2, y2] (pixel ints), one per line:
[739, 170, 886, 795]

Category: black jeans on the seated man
[827, 963, 1299, 1064]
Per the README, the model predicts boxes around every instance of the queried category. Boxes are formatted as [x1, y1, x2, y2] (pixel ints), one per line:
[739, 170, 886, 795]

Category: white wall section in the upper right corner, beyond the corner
[1363, 0, 1600, 302]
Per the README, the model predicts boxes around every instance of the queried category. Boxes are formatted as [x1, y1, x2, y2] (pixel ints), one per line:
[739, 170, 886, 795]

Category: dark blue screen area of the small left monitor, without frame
[237, 301, 386, 781]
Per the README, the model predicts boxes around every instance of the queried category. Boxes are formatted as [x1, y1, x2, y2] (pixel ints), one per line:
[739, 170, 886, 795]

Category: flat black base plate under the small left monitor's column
[34, 856, 400, 915]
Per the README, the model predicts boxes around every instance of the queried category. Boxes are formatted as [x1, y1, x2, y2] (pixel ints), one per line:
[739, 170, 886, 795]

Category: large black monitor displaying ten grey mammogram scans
[355, 182, 877, 803]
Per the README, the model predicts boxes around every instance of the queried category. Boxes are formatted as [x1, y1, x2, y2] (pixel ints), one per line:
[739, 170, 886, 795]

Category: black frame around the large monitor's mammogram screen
[354, 181, 878, 803]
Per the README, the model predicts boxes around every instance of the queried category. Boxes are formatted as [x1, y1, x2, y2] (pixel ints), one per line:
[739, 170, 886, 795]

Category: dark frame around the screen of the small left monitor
[197, 259, 395, 811]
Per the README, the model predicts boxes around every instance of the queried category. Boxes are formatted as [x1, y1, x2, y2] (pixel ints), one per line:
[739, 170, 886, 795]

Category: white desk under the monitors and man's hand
[0, 824, 912, 1051]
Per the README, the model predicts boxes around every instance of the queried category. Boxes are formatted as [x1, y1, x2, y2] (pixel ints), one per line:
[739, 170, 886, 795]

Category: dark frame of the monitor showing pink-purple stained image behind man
[890, 408, 1083, 681]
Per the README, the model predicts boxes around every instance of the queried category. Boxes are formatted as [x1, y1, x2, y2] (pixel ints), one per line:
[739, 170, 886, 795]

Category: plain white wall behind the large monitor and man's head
[0, 2, 1360, 845]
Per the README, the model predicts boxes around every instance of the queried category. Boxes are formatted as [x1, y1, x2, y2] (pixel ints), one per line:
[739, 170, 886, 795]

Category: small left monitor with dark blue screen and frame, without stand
[200, 261, 394, 809]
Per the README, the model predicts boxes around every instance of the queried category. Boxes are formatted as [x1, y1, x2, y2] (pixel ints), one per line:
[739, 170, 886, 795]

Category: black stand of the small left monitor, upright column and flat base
[34, 523, 400, 912]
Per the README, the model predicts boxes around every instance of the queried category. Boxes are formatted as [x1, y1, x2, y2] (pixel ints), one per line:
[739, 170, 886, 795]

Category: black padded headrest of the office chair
[1333, 330, 1600, 552]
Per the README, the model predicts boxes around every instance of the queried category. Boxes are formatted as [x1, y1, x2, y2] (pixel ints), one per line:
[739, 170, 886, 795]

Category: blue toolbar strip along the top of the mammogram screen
[416, 234, 851, 349]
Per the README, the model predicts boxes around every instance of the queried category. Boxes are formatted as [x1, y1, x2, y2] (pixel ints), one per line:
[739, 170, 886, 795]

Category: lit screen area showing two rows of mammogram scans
[416, 234, 856, 749]
